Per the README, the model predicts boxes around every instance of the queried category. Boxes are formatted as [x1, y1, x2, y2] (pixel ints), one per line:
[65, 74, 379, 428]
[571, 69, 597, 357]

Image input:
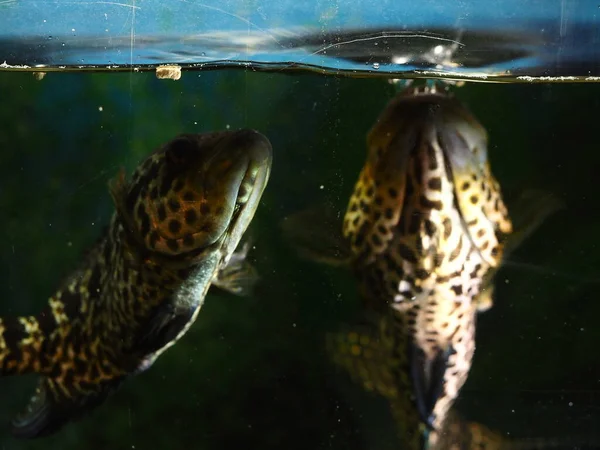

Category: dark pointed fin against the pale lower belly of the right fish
[409, 343, 454, 429]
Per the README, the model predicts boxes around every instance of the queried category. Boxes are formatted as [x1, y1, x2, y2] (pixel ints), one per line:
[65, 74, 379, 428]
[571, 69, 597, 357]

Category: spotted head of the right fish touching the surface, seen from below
[343, 87, 511, 265]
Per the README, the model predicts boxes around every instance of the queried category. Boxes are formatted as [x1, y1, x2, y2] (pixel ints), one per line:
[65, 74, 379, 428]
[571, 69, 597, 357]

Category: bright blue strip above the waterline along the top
[0, 0, 600, 82]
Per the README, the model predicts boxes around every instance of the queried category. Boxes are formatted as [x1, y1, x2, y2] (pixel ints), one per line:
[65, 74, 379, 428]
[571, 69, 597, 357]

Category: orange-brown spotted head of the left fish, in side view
[113, 130, 272, 258]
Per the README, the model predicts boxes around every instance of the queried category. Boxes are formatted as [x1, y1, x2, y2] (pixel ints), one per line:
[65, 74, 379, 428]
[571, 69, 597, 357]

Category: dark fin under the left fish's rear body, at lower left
[10, 376, 125, 439]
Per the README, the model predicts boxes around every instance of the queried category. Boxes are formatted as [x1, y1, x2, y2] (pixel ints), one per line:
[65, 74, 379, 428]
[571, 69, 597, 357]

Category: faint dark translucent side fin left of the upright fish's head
[281, 205, 352, 267]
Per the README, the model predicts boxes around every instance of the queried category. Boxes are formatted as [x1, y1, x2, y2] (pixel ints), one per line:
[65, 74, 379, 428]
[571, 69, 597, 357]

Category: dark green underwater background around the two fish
[0, 71, 600, 450]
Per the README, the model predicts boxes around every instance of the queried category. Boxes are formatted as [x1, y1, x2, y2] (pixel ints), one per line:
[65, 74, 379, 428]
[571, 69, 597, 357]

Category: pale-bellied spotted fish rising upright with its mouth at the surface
[281, 85, 562, 448]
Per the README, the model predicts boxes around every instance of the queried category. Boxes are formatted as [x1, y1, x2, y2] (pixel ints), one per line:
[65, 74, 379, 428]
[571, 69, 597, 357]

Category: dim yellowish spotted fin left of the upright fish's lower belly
[326, 322, 399, 399]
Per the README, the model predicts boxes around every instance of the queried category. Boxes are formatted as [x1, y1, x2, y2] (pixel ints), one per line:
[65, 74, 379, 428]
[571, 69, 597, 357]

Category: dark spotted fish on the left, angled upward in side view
[0, 129, 272, 439]
